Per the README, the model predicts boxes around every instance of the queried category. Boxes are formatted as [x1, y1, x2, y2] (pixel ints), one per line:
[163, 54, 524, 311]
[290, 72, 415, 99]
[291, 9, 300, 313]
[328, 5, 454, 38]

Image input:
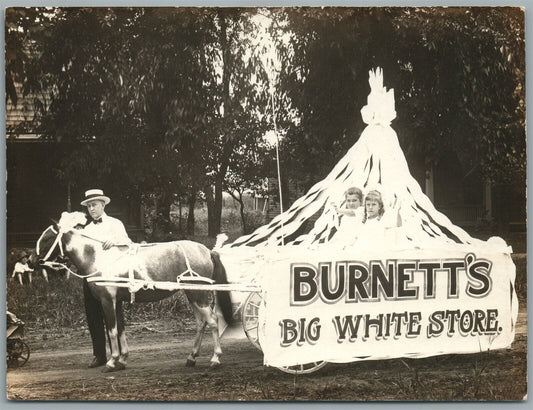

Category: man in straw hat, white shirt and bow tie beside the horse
[81, 189, 131, 368]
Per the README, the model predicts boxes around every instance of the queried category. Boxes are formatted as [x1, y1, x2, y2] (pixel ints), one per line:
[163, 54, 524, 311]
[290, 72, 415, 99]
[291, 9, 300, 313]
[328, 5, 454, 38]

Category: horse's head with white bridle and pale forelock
[35, 212, 87, 265]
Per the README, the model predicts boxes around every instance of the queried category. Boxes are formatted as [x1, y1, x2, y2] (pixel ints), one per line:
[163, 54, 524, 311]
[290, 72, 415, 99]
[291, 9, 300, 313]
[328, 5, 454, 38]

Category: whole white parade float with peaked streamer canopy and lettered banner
[218, 68, 518, 372]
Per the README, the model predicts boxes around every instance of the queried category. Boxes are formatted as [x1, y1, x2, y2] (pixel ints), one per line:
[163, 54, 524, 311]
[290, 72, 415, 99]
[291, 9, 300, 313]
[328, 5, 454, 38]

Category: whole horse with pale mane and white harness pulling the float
[36, 212, 232, 371]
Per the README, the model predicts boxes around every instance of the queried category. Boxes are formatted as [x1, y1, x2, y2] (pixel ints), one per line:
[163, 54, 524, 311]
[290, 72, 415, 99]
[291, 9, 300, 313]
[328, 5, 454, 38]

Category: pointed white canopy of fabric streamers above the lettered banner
[223, 67, 510, 252]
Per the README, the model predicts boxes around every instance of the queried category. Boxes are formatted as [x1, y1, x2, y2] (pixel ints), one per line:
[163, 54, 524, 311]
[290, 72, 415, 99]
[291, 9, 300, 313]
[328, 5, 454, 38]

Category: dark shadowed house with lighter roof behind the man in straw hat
[6, 82, 143, 248]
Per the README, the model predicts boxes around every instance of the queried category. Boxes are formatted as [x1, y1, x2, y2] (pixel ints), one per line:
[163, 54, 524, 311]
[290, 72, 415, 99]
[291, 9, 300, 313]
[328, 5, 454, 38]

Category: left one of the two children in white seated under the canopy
[332, 187, 364, 245]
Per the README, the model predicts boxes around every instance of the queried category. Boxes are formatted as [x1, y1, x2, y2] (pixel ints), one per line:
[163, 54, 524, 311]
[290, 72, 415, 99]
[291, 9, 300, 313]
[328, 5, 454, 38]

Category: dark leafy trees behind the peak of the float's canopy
[270, 8, 525, 192]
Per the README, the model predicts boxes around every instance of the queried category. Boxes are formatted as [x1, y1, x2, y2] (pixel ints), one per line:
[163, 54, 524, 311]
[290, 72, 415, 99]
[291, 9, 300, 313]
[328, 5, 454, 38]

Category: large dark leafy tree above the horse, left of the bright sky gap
[16, 8, 270, 234]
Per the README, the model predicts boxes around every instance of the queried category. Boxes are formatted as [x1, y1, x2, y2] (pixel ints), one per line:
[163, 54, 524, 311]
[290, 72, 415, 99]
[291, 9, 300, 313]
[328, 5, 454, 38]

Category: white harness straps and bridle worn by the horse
[36, 225, 215, 303]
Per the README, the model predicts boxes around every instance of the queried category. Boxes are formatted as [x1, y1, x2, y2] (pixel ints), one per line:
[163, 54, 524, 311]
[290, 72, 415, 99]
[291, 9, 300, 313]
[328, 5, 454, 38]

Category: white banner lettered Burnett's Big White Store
[259, 249, 518, 367]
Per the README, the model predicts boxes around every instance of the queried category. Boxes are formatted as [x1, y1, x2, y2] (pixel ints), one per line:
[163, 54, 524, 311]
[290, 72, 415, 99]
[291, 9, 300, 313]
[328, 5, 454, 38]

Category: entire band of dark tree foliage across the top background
[6, 7, 526, 235]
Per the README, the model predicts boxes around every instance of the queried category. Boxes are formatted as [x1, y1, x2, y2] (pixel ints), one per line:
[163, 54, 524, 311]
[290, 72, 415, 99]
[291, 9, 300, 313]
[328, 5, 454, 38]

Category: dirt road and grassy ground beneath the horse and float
[6, 309, 527, 401]
